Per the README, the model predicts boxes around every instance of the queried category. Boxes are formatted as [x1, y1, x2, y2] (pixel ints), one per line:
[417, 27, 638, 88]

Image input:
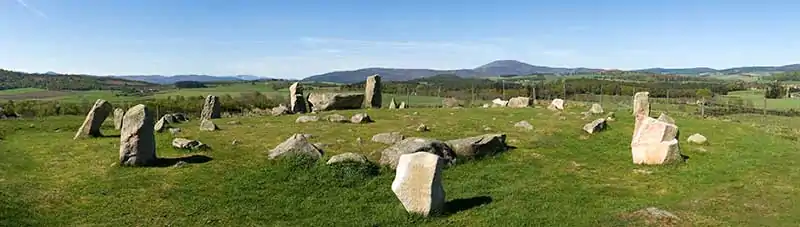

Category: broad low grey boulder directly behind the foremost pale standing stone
[380, 137, 456, 169]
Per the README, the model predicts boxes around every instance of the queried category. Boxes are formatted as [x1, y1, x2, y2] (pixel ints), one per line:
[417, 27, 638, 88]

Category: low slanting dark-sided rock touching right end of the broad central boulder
[446, 134, 508, 158]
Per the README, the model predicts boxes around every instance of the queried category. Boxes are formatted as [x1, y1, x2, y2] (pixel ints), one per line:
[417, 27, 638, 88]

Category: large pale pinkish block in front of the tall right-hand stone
[631, 115, 683, 165]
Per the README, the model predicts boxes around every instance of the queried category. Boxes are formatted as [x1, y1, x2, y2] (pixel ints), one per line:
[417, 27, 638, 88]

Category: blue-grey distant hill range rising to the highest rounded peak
[303, 60, 602, 83]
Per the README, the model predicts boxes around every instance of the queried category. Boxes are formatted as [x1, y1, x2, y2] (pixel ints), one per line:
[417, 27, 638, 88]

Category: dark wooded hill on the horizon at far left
[0, 69, 158, 90]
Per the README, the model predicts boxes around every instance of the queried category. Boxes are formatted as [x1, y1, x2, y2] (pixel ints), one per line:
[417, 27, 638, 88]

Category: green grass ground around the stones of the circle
[0, 104, 800, 226]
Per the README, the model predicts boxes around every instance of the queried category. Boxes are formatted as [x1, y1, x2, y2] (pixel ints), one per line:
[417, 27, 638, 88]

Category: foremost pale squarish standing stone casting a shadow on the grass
[392, 152, 445, 216]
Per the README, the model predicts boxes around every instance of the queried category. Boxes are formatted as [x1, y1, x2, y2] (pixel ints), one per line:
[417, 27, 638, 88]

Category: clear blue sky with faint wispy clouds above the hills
[0, 0, 800, 78]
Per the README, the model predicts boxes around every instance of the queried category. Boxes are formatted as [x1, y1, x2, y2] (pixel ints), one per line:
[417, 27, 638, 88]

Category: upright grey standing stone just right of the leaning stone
[119, 104, 158, 166]
